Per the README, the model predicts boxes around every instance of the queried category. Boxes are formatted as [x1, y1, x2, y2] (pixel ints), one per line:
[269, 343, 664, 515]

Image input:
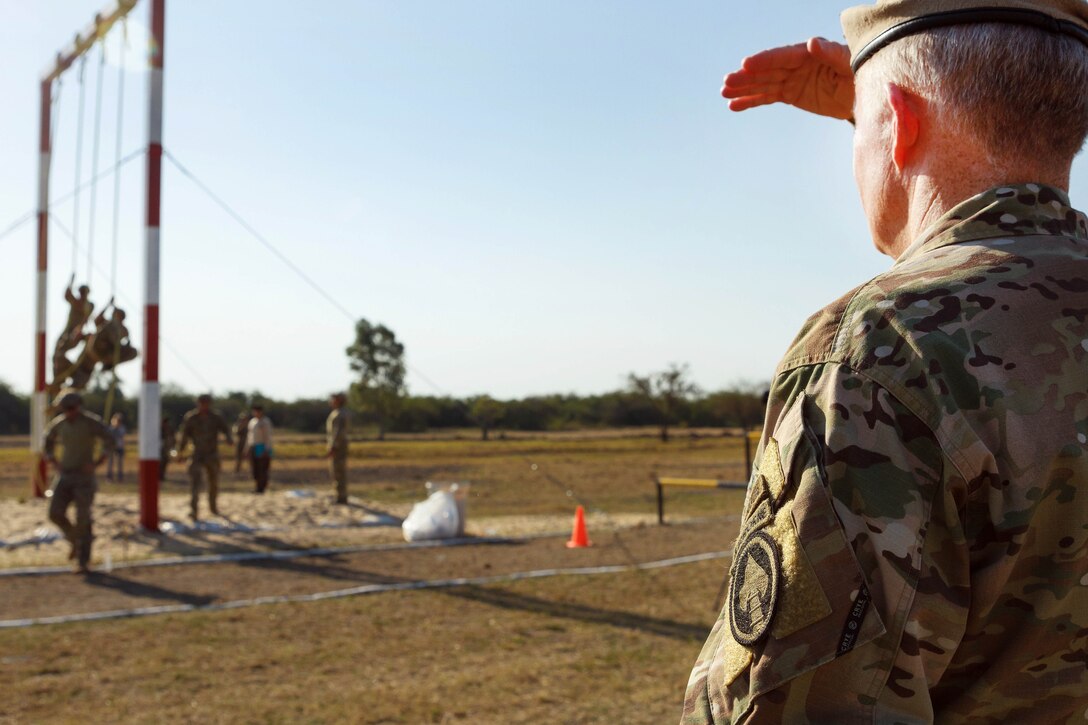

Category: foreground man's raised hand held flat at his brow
[721, 38, 854, 120]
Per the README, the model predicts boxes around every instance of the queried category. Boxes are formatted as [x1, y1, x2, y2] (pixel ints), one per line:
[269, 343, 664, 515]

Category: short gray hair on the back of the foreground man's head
[858, 23, 1088, 165]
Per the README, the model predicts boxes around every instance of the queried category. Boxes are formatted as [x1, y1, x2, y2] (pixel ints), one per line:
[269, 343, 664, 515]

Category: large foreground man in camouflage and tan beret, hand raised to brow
[682, 0, 1088, 724]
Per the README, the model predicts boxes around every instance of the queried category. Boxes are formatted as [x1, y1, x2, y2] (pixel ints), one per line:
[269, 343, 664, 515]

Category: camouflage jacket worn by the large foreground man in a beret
[682, 184, 1088, 724]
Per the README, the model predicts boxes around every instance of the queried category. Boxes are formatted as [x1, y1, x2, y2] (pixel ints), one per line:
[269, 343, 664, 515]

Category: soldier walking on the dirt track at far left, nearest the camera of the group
[44, 393, 113, 574]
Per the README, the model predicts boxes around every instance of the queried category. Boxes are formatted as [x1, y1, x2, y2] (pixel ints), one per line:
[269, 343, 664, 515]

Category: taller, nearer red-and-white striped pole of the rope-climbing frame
[139, 0, 165, 531]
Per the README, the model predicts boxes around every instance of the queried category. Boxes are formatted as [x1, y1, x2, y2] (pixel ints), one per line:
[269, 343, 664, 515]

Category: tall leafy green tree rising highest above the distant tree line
[347, 318, 407, 440]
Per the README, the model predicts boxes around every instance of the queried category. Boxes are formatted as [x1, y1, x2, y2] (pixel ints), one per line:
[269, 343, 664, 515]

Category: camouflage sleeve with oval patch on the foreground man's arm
[683, 364, 968, 724]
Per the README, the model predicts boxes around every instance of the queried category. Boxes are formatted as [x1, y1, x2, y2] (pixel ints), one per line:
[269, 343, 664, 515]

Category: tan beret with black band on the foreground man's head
[842, 0, 1088, 73]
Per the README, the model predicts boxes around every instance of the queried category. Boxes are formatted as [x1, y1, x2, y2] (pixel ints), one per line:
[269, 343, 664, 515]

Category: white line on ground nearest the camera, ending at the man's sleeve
[0, 551, 732, 629]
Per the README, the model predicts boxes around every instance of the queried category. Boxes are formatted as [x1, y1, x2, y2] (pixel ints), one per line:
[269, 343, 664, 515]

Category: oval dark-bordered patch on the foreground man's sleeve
[729, 531, 782, 646]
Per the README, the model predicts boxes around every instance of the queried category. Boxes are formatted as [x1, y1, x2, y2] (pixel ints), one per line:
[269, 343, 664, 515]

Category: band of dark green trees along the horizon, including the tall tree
[0, 319, 766, 441]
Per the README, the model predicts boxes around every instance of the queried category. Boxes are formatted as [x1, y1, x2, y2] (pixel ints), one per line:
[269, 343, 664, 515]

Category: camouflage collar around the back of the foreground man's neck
[895, 184, 1088, 265]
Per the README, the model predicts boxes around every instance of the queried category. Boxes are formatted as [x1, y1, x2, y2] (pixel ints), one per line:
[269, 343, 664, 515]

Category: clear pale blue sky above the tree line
[0, 0, 1085, 397]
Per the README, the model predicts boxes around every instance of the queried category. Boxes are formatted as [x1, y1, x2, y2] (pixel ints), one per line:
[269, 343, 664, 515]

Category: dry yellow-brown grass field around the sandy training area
[0, 431, 744, 723]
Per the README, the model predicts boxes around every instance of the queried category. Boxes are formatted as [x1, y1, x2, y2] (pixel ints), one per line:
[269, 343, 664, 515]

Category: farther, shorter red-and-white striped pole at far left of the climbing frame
[30, 79, 53, 497]
